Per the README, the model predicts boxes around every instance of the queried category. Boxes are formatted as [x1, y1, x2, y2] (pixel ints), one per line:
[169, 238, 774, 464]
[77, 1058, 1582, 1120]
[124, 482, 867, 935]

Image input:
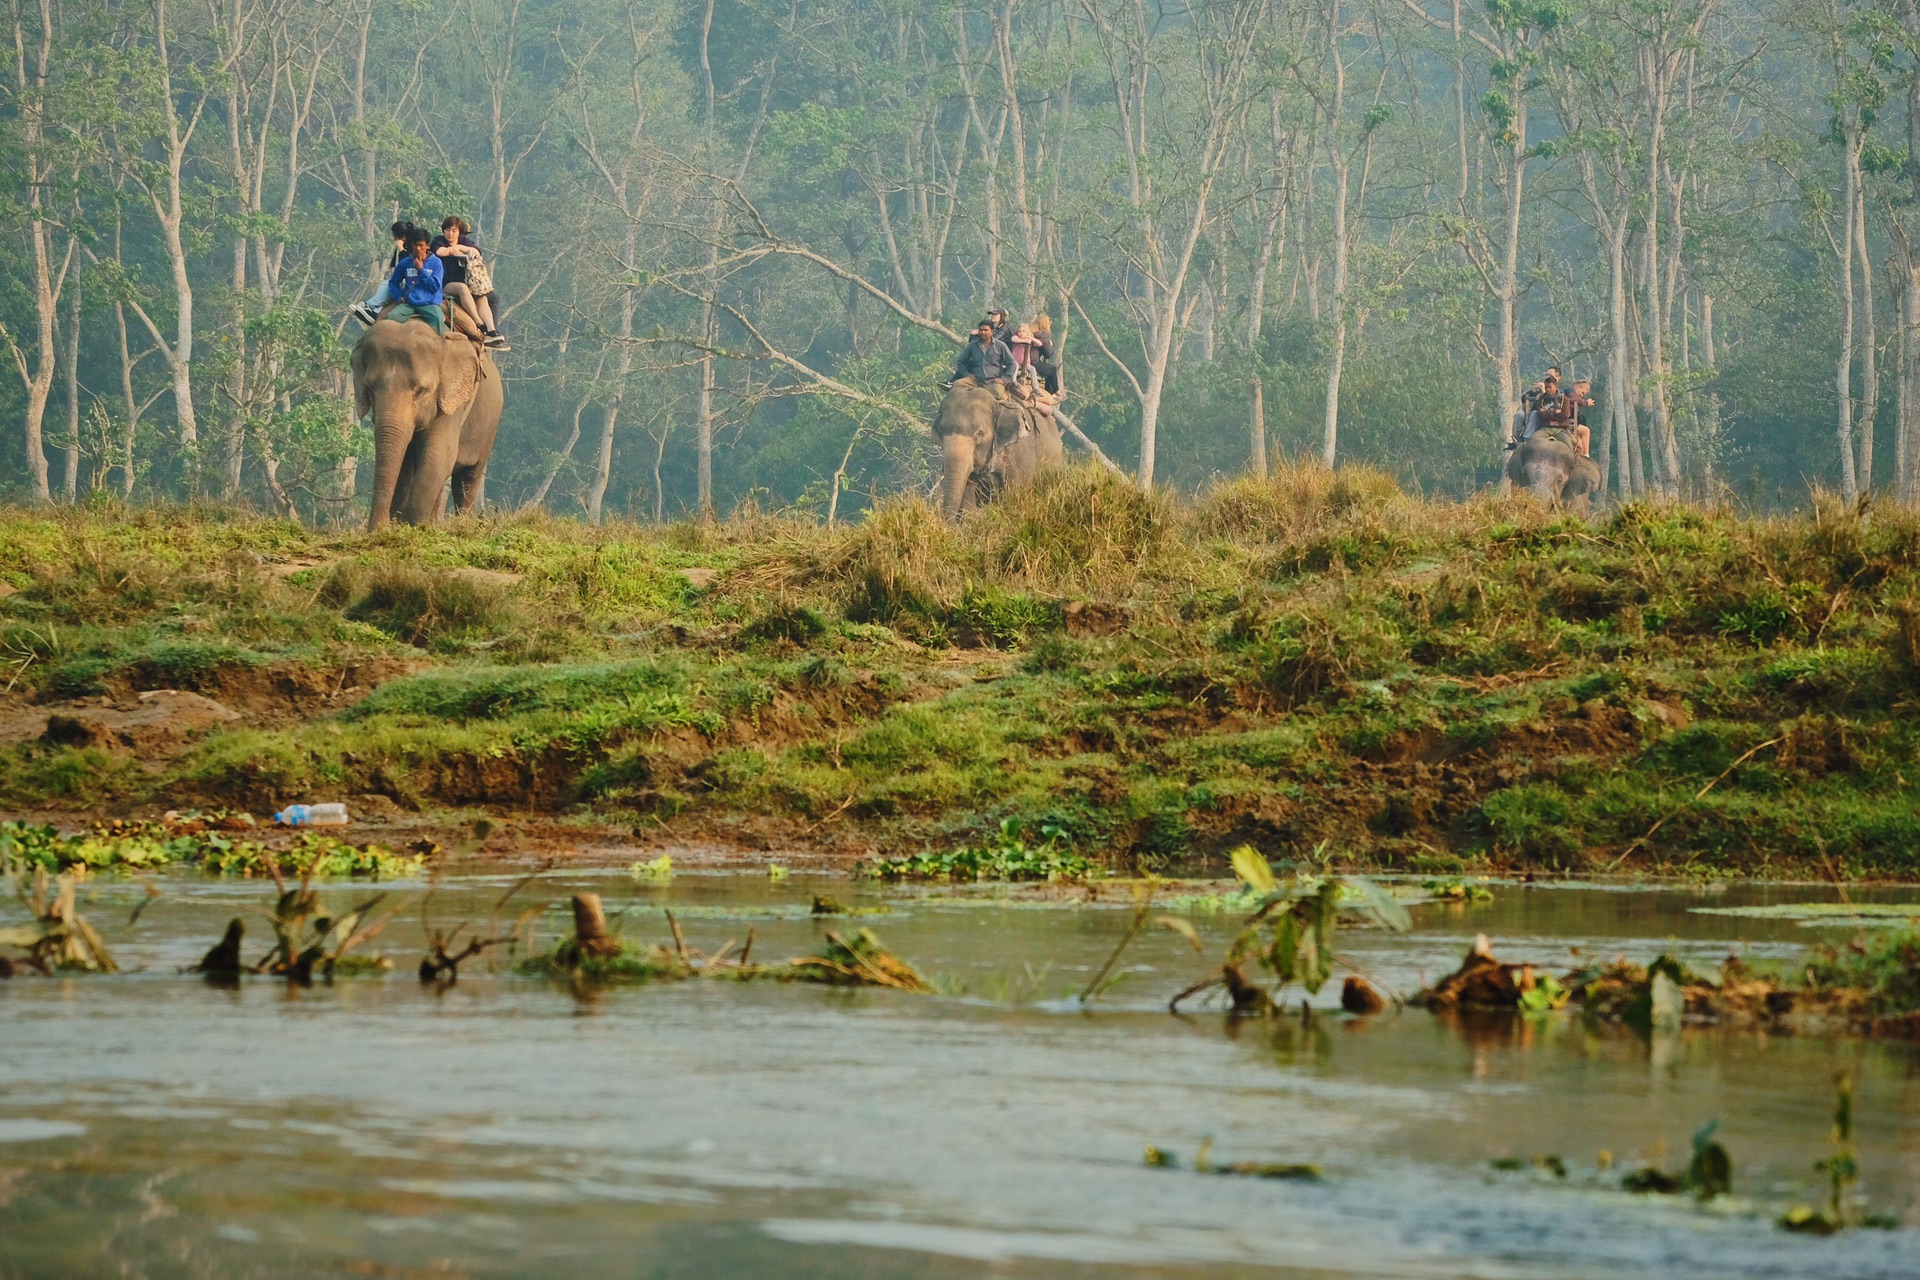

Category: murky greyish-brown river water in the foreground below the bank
[0, 875, 1920, 1280]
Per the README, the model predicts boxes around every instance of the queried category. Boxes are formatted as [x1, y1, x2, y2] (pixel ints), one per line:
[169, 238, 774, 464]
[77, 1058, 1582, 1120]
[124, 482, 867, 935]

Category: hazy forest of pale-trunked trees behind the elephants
[0, 0, 1920, 526]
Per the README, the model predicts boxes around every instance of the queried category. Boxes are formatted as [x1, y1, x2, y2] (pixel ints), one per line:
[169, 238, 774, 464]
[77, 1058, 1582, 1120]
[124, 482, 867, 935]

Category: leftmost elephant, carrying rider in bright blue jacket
[353, 320, 505, 530]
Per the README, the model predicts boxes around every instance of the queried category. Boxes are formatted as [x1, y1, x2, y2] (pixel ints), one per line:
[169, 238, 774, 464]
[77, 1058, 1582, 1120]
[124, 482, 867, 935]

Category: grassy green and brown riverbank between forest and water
[0, 468, 1920, 875]
